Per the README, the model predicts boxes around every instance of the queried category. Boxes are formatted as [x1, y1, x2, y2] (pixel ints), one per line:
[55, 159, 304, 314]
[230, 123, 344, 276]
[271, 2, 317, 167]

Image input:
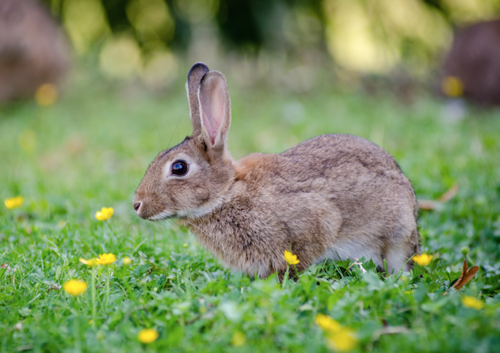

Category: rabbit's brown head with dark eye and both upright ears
[133, 63, 235, 220]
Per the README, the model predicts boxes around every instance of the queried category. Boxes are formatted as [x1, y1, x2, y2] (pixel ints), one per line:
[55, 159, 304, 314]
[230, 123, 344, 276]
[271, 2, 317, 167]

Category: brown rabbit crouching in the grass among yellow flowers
[133, 63, 419, 278]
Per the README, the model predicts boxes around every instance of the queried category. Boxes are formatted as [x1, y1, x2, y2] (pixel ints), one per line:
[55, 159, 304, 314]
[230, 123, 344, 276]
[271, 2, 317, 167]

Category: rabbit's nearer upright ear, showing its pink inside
[198, 71, 231, 149]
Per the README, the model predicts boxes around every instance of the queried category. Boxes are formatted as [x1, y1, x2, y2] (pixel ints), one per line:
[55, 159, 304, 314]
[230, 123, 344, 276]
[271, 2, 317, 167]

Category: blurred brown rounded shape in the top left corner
[0, 0, 69, 102]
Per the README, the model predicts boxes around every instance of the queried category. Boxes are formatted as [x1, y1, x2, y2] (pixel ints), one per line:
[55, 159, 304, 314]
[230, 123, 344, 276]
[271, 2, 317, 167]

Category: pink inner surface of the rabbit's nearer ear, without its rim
[200, 82, 225, 146]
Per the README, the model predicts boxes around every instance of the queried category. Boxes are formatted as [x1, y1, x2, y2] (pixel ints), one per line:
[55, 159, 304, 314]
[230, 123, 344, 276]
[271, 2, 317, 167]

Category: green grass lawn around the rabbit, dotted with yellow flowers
[0, 67, 500, 352]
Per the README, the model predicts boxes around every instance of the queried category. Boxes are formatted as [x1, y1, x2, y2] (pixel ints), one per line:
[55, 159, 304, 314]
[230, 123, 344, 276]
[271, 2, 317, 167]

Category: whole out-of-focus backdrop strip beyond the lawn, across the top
[0, 0, 500, 104]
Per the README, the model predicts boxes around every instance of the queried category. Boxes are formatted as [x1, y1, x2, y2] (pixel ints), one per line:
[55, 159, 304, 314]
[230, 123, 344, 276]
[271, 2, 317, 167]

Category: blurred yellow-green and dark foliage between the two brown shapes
[42, 0, 500, 72]
